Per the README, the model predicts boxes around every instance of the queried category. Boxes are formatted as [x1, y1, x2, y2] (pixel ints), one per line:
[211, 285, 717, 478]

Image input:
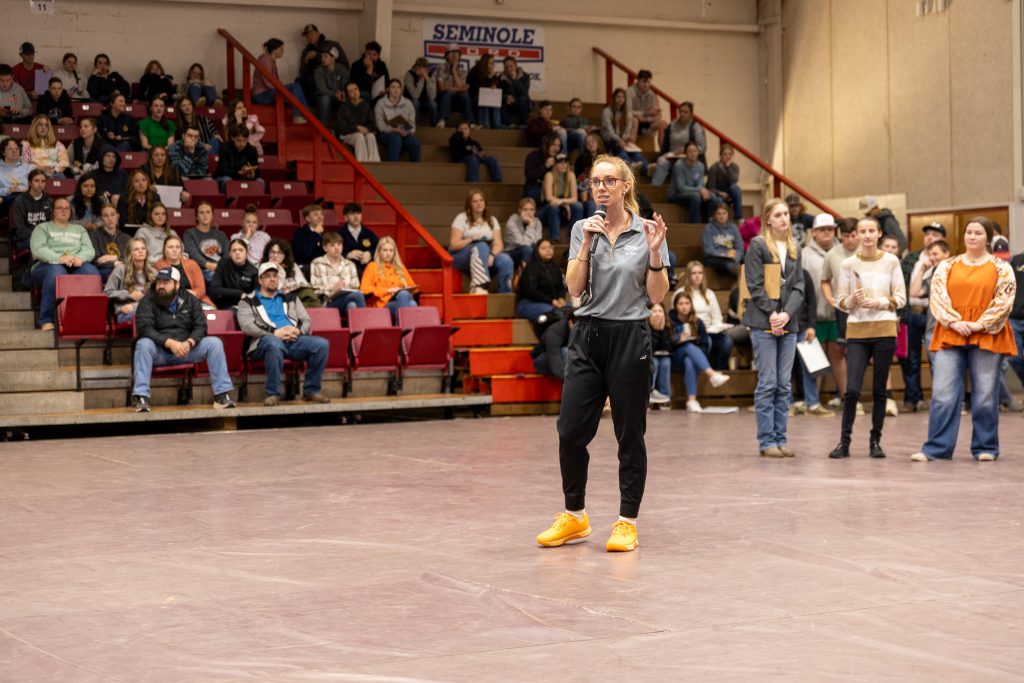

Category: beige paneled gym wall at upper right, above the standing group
[782, 0, 1014, 210]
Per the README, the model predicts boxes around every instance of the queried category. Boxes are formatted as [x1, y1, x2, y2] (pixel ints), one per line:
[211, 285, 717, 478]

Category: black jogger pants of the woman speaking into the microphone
[558, 317, 650, 517]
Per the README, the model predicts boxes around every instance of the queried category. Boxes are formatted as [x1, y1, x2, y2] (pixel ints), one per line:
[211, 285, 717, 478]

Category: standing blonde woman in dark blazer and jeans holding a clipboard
[743, 198, 804, 458]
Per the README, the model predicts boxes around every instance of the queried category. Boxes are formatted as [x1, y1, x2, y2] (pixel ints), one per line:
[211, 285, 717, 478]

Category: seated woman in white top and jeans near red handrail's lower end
[449, 189, 513, 294]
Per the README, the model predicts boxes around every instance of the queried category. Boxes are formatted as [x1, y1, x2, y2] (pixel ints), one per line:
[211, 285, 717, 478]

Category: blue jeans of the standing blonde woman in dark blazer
[751, 330, 797, 451]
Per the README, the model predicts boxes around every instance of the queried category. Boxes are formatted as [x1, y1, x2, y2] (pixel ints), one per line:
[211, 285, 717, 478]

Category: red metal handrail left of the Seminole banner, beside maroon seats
[217, 29, 455, 325]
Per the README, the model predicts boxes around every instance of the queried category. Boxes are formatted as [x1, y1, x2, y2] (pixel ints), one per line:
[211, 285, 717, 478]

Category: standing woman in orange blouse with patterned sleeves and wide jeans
[910, 217, 1017, 462]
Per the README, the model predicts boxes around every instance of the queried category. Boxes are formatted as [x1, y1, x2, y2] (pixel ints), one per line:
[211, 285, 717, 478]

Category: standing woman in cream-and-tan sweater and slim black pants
[828, 218, 906, 458]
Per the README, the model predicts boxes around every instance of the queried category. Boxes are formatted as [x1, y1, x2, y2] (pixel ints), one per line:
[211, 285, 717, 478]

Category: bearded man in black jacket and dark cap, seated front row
[131, 267, 236, 413]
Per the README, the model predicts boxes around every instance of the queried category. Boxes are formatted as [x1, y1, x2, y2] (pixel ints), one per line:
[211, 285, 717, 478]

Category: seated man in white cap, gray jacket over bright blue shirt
[238, 263, 331, 407]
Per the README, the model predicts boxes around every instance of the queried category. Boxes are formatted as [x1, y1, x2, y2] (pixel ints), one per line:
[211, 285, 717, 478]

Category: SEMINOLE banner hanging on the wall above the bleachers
[423, 17, 544, 93]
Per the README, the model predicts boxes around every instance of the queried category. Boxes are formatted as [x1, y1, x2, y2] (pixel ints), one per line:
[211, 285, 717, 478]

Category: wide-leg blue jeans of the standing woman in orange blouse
[921, 345, 1002, 460]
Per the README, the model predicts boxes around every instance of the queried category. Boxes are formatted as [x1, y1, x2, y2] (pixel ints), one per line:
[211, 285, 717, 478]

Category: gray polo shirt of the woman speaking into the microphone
[569, 215, 669, 321]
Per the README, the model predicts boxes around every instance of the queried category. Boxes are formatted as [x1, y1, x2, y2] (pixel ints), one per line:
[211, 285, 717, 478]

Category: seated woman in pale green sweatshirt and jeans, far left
[31, 197, 99, 330]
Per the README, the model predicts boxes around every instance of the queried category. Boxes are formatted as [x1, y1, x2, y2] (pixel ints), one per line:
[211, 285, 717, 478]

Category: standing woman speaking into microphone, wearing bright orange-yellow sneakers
[537, 156, 669, 552]
